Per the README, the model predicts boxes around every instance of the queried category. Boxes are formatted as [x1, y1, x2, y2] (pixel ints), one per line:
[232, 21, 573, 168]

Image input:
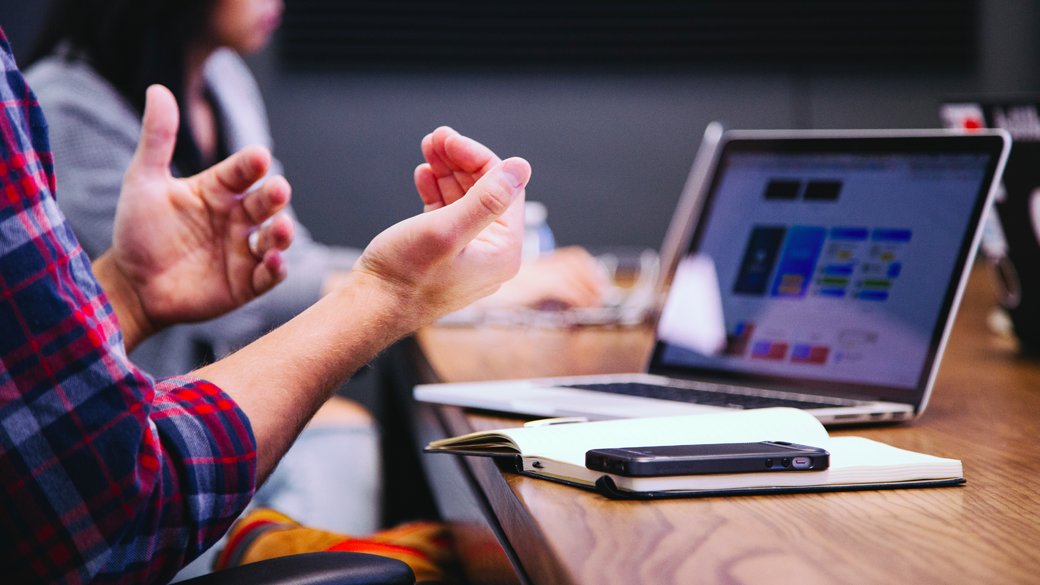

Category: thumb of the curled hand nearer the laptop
[427, 157, 530, 248]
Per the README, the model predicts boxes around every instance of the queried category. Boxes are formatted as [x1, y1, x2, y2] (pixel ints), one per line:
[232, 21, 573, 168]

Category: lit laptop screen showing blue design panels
[651, 136, 1000, 402]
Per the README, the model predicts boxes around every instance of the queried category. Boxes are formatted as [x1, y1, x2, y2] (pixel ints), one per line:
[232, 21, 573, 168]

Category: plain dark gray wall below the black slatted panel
[0, 0, 1040, 248]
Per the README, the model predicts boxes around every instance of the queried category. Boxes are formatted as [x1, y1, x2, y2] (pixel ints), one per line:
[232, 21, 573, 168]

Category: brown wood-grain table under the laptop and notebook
[403, 269, 1040, 585]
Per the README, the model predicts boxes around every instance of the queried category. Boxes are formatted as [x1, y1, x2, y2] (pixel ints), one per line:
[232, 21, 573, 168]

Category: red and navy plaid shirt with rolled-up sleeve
[0, 31, 256, 584]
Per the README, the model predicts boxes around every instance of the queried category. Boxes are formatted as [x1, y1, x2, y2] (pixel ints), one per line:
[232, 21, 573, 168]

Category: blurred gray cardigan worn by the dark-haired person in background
[26, 49, 360, 376]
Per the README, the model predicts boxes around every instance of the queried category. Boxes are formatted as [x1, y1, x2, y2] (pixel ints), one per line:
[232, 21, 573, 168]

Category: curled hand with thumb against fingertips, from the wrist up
[354, 127, 530, 330]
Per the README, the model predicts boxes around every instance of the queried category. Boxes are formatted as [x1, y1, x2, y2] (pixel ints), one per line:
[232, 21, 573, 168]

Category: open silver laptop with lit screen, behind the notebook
[414, 130, 1011, 425]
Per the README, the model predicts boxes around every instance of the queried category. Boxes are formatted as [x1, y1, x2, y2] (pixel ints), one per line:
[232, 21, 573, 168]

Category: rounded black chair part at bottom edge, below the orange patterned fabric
[175, 553, 415, 585]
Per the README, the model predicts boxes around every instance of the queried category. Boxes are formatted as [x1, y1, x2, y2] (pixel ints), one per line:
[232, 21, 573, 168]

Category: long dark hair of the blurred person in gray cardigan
[27, 0, 216, 175]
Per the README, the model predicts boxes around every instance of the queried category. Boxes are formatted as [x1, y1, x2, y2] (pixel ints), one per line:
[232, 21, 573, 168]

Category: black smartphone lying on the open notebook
[586, 440, 830, 478]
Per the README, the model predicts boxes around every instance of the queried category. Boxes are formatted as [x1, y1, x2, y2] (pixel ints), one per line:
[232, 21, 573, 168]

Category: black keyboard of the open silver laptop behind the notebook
[562, 382, 862, 410]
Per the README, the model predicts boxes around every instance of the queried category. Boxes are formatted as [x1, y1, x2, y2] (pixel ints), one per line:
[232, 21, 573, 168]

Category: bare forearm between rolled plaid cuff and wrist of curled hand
[192, 272, 411, 481]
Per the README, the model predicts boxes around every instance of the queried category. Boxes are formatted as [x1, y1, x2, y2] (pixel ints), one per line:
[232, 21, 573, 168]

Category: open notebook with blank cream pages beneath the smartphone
[426, 408, 964, 499]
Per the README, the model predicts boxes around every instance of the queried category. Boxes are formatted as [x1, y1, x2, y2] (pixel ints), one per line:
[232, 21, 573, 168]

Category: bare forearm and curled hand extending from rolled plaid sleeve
[196, 128, 530, 480]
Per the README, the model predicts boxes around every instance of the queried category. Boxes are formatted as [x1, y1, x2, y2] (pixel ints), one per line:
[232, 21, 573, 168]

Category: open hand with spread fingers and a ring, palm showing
[95, 85, 294, 351]
